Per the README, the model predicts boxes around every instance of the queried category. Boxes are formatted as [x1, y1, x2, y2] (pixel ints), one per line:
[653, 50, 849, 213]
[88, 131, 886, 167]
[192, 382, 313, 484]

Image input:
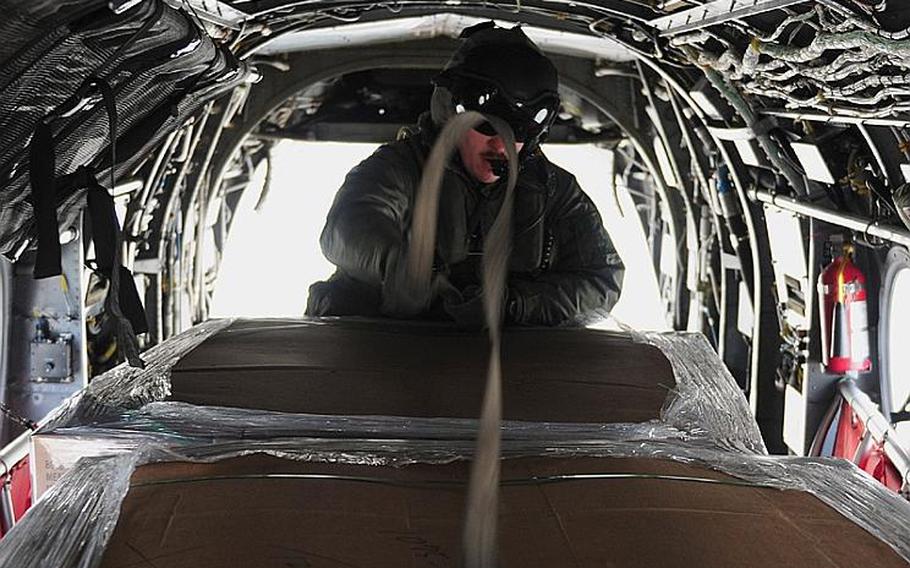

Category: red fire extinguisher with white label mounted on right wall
[818, 243, 872, 374]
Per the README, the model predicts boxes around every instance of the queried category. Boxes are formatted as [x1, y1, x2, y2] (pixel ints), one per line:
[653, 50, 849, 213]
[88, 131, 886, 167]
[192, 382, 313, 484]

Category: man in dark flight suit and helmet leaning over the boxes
[307, 22, 624, 328]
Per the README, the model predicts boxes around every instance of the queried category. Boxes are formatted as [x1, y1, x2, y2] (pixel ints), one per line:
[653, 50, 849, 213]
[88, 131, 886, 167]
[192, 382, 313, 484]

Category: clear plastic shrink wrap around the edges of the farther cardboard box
[41, 319, 767, 454]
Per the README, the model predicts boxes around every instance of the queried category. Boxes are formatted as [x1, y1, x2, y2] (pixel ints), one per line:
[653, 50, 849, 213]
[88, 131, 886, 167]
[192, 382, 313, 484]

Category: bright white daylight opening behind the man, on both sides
[211, 140, 668, 330]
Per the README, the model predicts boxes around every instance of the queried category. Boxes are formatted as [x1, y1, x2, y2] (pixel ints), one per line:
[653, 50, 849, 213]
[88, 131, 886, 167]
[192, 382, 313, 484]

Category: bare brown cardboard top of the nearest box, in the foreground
[102, 456, 906, 568]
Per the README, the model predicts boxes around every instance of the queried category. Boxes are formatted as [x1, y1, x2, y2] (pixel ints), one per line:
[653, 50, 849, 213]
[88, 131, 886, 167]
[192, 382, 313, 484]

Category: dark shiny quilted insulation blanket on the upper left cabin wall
[0, 0, 248, 258]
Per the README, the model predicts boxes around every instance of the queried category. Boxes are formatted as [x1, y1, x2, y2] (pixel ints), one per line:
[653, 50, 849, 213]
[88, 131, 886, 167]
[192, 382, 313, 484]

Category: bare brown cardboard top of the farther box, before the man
[170, 320, 676, 423]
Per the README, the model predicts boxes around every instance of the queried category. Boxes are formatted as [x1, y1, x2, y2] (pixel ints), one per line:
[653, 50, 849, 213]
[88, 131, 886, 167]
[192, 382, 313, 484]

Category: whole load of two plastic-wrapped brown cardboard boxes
[0, 320, 910, 567]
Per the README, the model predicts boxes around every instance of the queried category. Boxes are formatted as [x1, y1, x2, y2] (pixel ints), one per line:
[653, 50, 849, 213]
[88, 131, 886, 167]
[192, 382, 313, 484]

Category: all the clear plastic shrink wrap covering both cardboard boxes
[0, 320, 910, 568]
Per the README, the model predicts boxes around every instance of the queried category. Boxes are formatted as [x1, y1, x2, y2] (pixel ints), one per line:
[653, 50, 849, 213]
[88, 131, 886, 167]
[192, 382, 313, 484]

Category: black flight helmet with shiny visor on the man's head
[434, 22, 559, 155]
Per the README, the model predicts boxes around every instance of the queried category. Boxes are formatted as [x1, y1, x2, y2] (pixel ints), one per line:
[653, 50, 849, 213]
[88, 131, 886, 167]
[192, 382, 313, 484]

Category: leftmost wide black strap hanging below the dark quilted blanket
[29, 120, 63, 278]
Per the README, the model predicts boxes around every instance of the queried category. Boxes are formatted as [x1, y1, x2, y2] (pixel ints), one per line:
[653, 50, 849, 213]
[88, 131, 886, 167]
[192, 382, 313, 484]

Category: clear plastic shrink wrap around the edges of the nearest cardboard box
[0, 434, 910, 568]
